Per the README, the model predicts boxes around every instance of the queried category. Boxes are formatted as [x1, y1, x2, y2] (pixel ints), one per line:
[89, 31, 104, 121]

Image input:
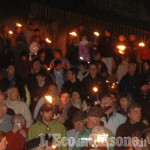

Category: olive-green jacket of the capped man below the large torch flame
[27, 120, 68, 150]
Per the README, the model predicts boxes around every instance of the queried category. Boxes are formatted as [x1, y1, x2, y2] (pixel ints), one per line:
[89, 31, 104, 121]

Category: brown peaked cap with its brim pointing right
[87, 106, 110, 118]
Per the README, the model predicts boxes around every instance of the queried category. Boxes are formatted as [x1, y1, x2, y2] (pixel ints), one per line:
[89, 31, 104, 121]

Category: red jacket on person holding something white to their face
[7, 128, 28, 150]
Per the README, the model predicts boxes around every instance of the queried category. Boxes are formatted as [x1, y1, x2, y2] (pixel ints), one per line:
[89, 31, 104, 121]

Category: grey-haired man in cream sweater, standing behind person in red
[6, 87, 33, 128]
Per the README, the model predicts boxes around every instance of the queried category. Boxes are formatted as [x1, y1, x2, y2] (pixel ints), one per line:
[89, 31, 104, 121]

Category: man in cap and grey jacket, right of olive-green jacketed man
[67, 111, 90, 150]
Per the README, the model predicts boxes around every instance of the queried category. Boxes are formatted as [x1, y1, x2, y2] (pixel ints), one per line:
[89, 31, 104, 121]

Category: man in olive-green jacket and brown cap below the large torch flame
[27, 103, 67, 150]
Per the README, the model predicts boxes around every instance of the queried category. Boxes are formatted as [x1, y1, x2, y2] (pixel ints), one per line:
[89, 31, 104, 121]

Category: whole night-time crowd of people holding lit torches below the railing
[0, 23, 150, 150]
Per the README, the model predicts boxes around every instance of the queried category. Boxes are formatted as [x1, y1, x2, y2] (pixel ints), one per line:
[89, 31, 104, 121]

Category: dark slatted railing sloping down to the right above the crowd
[31, 2, 150, 40]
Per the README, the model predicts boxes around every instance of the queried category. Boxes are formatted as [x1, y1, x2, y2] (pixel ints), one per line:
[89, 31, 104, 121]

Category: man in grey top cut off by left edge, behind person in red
[0, 102, 12, 132]
